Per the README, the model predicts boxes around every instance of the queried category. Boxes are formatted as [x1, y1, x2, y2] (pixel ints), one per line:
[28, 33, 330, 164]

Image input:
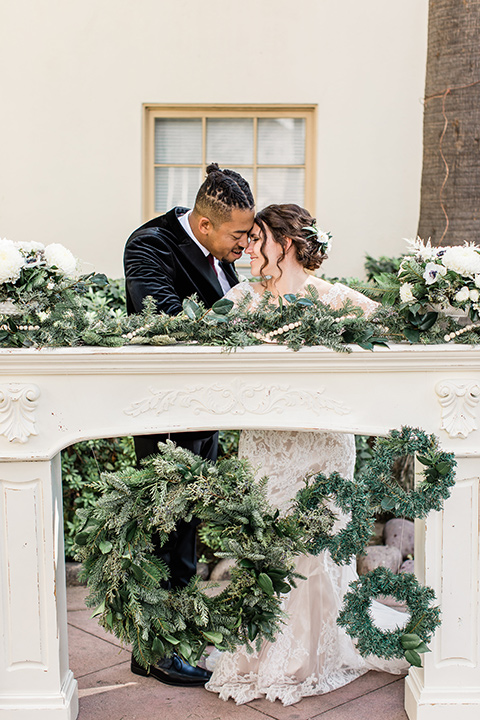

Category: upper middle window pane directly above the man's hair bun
[207, 118, 253, 167]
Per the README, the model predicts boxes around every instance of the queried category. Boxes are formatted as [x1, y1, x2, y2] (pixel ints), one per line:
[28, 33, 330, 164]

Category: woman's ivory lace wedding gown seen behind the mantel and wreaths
[205, 283, 406, 705]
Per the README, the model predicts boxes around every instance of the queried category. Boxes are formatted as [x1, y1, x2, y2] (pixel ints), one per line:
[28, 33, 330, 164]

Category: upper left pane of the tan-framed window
[155, 118, 202, 164]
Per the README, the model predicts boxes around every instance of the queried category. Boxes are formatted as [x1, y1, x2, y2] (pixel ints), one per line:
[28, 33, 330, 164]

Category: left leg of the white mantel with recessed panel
[0, 455, 78, 720]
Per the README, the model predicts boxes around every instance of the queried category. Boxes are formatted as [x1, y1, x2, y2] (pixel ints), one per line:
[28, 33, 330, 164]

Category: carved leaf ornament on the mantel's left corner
[0, 383, 40, 443]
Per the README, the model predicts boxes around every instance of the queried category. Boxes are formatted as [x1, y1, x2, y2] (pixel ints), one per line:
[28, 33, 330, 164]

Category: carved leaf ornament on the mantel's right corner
[435, 380, 480, 438]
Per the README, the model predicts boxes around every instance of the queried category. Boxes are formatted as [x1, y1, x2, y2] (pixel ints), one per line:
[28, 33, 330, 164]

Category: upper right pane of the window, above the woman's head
[257, 118, 305, 165]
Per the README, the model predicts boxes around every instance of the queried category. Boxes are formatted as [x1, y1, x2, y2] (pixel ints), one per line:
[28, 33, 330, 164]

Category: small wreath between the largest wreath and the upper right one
[296, 472, 375, 565]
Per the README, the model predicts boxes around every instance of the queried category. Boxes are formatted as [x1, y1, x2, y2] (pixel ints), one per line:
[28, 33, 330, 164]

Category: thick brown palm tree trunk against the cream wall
[418, 0, 480, 245]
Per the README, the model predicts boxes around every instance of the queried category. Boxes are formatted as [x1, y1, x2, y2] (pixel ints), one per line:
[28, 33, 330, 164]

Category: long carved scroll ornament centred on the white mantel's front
[124, 382, 350, 417]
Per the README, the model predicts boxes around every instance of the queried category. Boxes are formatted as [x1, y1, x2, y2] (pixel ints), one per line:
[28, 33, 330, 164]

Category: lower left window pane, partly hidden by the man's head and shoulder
[155, 168, 202, 213]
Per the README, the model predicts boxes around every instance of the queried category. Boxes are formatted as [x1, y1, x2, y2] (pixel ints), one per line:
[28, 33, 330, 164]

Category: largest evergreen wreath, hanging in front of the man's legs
[75, 442, 330, 667]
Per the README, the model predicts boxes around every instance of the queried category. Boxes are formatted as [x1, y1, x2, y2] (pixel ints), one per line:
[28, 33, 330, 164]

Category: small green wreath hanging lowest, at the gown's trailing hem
[337, 567, 440, 667]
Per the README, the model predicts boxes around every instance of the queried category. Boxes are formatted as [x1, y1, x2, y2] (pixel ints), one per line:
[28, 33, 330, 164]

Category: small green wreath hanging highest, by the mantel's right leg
[362, 426, 457, 518]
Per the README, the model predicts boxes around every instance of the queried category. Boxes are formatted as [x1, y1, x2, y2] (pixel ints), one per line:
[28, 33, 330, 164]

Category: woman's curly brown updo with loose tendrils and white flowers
[255, 203, 328, 277]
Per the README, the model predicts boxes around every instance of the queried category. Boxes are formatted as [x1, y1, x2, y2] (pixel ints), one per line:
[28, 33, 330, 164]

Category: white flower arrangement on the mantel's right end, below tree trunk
[398, 238, 480, 321]
